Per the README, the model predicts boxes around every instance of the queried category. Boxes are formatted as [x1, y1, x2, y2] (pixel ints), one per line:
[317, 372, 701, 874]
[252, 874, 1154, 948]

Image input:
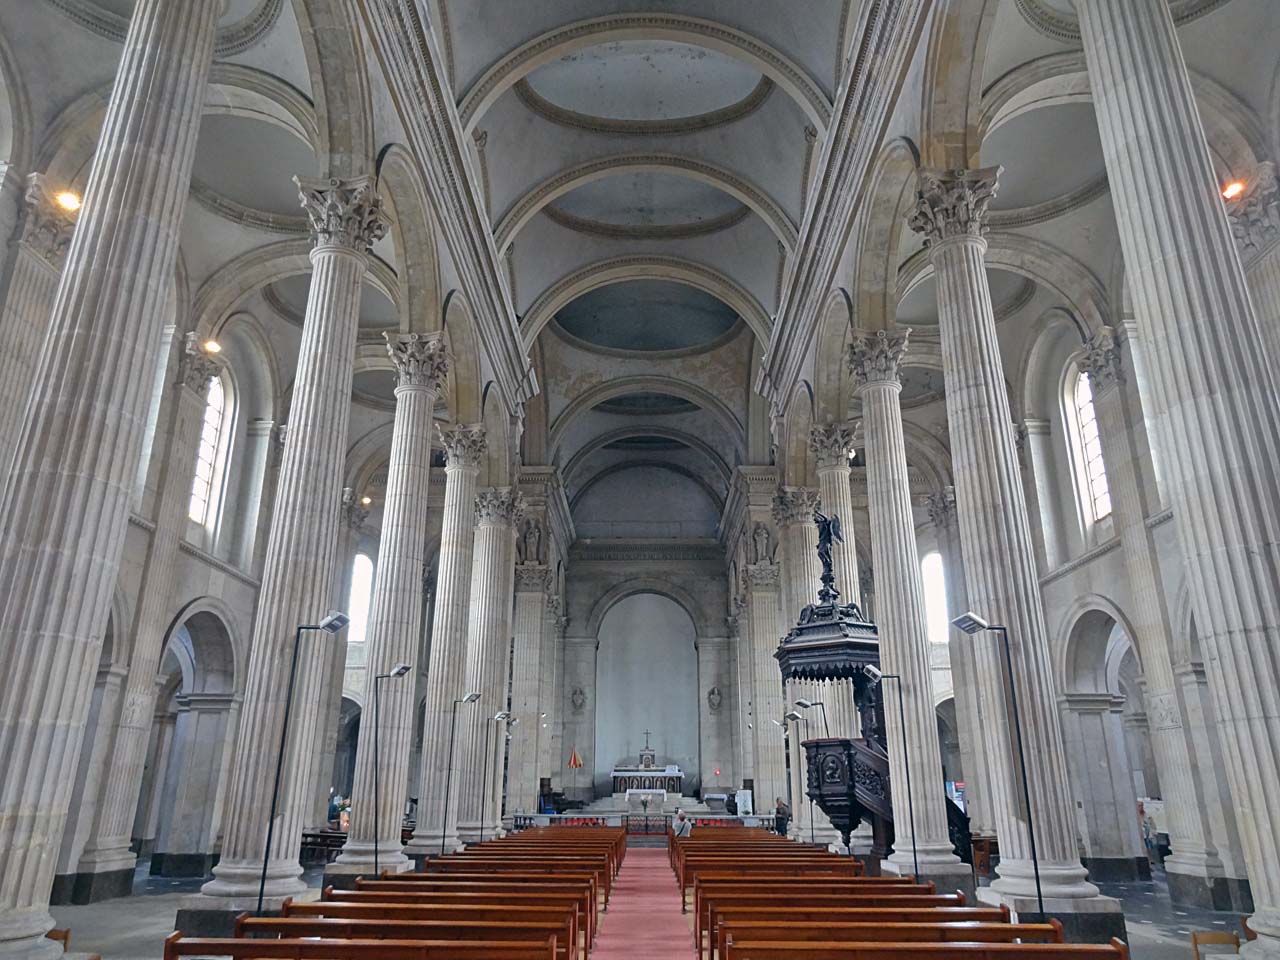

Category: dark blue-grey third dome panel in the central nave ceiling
[556, 280, 737, 352]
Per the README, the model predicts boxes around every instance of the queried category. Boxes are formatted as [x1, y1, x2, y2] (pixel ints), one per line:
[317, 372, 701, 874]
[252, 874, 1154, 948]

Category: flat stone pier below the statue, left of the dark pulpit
[746, 559, 787, 814]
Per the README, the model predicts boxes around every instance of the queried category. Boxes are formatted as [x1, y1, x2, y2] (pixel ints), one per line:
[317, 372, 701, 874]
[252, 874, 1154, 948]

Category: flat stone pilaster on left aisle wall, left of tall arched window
[78, 338, 223, 900]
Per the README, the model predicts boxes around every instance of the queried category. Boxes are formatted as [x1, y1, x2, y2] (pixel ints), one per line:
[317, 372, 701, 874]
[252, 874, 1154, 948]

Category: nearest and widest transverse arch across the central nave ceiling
[458, 13, 831, 133]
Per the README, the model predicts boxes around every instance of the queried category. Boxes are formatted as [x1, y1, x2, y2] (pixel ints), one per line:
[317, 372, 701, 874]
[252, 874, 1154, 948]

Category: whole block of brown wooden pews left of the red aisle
[164, 827, 626, 960]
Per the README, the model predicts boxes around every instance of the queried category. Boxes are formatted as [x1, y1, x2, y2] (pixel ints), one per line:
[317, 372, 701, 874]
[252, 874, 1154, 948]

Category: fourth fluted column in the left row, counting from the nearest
[404, 424, 492, 859]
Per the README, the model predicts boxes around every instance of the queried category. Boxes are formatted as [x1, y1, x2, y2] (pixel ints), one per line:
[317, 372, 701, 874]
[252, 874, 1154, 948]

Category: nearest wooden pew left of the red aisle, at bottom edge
[164, 931, 556, 960]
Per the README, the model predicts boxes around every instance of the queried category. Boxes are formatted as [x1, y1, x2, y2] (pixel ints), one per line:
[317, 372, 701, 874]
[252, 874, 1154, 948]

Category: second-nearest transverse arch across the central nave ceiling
[493, 154, 797, 251]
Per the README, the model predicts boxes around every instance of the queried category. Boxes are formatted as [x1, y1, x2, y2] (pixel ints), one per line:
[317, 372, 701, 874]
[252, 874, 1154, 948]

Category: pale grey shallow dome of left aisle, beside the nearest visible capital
[192, 114, 316, 216]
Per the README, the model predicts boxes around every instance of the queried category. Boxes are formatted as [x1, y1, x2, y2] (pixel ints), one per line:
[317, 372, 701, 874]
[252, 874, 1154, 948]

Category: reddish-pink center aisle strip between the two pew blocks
[591, 847, 694, 960]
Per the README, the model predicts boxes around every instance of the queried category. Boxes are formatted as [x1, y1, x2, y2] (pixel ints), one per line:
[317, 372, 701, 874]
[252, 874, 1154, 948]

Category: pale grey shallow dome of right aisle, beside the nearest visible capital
[982, 104, 1106, 210]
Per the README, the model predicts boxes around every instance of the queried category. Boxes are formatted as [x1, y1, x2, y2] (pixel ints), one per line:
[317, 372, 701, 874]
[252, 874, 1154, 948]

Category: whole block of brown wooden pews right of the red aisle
[668, 829, 1128, 960]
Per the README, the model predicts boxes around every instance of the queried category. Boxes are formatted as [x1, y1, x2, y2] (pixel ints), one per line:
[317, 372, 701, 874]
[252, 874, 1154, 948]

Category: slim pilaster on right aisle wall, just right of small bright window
[928, 486, 996, 837]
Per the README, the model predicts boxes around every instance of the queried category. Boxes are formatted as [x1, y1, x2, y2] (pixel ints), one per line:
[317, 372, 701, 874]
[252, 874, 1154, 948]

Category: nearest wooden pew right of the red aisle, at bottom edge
[724, 938, 1129, 960]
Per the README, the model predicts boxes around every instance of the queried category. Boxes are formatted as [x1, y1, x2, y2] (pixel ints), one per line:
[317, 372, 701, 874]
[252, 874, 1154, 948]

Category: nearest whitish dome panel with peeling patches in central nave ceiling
[526, 40, 762, 123]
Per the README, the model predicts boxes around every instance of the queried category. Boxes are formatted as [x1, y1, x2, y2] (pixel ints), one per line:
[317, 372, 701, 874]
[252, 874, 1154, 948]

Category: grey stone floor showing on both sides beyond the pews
[52, 850, 1240, 960]
